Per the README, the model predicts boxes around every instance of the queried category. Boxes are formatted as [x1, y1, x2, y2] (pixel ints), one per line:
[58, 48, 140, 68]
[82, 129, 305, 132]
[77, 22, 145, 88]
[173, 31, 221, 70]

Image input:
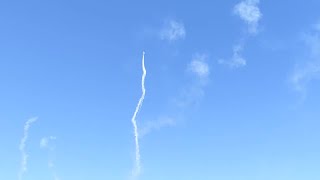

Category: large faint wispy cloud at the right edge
[290, 24, 320, 95]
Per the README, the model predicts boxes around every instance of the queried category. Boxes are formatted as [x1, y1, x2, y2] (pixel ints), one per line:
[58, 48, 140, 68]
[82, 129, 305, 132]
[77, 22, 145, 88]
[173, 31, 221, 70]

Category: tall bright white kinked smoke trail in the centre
[131, 51, 147, 177]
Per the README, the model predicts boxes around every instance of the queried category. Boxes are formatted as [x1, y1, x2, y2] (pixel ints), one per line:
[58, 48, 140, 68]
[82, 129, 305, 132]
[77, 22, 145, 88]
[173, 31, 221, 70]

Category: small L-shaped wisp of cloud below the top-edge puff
[218, 44, 247, 68]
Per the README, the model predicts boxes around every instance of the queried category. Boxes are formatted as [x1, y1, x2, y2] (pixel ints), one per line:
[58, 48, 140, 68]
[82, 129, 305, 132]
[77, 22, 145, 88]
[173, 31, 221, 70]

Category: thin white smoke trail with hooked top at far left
[18, 117, 38, 180]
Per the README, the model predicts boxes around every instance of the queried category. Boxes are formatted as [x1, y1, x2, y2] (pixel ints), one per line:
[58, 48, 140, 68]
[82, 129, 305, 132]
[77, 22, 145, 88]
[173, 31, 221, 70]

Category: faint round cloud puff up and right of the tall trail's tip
[160, 20, 186, 42]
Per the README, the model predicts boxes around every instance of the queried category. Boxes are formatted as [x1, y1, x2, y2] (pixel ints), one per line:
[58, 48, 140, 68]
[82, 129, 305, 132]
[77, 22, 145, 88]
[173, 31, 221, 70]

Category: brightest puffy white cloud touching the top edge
[234, 0, 262, 34]
